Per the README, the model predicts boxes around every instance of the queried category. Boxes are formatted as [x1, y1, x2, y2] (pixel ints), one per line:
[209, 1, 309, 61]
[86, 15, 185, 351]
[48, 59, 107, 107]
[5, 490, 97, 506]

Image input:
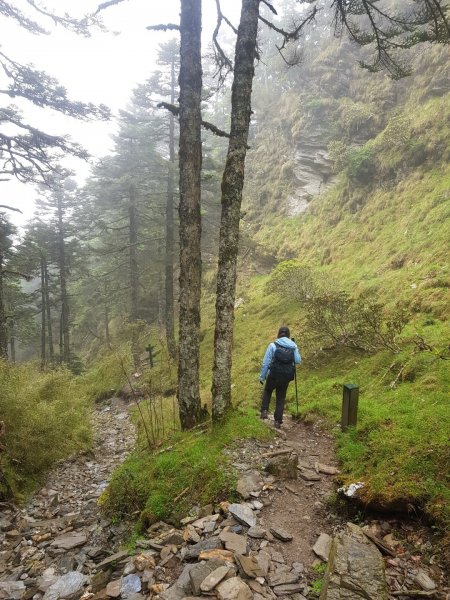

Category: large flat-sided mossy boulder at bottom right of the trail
[320, 523, 388, 600]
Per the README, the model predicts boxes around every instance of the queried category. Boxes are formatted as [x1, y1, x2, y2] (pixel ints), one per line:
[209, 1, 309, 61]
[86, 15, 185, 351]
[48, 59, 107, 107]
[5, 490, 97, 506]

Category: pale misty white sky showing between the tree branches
[0, 0, 241, 223]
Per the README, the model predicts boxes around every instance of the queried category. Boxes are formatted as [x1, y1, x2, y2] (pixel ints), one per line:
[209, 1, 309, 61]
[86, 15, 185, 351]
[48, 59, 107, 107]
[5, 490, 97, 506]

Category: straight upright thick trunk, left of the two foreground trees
[178, 0, 206, 429]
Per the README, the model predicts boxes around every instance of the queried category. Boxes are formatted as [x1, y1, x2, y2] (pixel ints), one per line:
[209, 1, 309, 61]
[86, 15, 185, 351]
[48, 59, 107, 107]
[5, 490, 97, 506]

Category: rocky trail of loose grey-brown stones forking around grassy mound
[0, 399, 448, 600]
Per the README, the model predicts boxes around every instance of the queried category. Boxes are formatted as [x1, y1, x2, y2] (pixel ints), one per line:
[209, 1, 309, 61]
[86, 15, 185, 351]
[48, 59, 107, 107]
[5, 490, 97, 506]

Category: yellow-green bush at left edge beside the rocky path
[0, 361, 90, 498]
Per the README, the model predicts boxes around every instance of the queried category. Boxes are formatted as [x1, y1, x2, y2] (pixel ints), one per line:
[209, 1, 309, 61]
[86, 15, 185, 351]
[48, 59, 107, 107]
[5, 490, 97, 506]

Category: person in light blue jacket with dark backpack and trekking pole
[259, 326, 302, 429]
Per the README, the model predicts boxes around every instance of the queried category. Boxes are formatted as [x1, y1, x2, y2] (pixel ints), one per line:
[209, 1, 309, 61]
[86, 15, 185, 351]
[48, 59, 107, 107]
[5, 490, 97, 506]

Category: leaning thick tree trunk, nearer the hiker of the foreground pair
[212, 0, 260, 421]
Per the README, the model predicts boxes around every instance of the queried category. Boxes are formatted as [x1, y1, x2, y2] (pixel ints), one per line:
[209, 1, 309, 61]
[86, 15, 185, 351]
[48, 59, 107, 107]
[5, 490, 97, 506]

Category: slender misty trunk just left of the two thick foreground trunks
[164, 57, 177, 358]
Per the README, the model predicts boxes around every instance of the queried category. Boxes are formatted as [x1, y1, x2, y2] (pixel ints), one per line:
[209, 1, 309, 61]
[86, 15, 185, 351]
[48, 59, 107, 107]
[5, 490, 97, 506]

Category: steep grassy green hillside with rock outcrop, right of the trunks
[214, 42, 450, 521]
